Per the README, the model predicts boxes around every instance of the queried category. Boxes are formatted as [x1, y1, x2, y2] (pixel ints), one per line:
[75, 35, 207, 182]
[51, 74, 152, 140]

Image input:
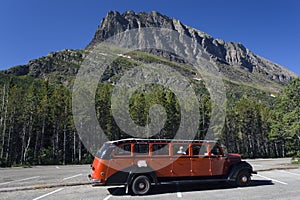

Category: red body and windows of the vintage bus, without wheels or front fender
[89, 139, 241, 185]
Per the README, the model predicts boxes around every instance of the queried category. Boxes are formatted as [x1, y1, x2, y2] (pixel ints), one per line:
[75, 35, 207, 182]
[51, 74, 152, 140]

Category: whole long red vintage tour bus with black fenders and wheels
[88, 138, 256, 195]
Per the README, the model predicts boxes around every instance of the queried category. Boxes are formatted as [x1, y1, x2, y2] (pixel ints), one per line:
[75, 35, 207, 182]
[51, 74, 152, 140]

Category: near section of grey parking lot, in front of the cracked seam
[0, 169, 300, 200]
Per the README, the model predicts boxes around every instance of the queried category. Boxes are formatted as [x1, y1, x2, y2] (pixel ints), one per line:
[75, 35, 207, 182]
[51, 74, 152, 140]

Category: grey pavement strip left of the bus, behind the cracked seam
[0, 165, 90, 192]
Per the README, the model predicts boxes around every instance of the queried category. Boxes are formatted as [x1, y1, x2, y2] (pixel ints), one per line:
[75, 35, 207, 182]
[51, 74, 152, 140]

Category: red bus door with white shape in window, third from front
[171, 144, 191, 177]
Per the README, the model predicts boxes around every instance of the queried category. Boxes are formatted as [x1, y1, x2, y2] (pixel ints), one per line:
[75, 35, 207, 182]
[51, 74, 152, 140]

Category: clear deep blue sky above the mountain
[0, 0, 300, 75]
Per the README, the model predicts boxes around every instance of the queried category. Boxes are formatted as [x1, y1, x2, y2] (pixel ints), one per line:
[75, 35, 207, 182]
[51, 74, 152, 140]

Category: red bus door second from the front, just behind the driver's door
[191, 144, 211, 176]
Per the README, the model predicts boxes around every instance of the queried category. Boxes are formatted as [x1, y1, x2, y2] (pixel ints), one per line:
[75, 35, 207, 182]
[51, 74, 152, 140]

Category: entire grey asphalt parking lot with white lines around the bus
[0, 159, 300, 200]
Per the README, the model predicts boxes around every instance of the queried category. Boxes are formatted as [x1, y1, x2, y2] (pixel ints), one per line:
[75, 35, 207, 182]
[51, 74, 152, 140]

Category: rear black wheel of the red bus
[131, 175, 151, 195]
